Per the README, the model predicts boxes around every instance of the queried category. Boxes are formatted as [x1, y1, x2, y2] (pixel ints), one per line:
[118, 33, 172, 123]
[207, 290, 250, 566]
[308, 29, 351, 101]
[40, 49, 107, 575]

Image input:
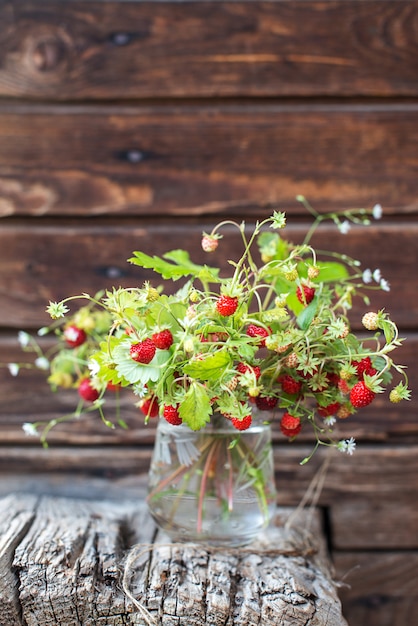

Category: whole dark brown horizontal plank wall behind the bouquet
[0, 0, 418, 626]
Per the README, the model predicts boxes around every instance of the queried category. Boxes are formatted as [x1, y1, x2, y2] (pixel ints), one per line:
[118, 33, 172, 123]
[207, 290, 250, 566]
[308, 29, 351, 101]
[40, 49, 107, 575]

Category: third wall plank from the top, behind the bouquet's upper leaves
[0, 218, 418, 326]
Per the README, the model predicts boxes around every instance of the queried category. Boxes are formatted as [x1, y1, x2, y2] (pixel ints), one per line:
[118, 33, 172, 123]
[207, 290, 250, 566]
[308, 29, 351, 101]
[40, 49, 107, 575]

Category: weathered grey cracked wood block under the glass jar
[0, 493, 347, 626]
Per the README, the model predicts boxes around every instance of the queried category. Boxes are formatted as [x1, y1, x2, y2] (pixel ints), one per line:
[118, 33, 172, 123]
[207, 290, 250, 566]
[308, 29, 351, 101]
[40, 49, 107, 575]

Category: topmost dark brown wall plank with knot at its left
[0, 0, 418, 100]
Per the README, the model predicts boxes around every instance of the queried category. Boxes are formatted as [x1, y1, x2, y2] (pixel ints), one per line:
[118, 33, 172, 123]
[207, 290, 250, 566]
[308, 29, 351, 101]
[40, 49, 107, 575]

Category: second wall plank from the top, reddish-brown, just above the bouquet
[0, 103, 418, 218]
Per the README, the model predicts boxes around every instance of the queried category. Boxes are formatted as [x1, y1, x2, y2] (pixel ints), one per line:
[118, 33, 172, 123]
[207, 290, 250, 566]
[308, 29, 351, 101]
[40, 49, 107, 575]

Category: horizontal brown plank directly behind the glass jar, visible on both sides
[0, 442, 418, 507]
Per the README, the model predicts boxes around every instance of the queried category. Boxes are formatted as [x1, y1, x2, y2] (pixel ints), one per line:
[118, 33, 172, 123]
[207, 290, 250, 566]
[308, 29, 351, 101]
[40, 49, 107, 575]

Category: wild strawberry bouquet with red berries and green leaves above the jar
[11, 197, 410, 460]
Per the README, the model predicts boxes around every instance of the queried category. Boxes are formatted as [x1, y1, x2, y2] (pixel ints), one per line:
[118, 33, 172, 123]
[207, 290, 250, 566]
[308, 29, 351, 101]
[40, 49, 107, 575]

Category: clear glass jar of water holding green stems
[148, 416, 276, 546]
